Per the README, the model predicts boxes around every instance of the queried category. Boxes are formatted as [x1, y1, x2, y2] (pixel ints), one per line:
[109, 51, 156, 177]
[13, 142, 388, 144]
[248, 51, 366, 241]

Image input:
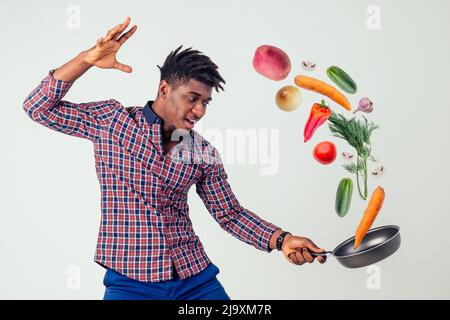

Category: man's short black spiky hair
[158, 45, 225, 92]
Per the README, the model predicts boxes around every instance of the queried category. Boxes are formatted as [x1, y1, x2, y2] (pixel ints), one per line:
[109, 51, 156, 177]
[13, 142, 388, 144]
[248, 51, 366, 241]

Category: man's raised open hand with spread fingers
[84, 17, 137, 73]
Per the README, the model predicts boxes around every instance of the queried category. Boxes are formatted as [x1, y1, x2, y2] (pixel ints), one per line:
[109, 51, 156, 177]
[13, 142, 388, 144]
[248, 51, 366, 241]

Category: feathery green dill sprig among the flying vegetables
[328, 112, 379, 200]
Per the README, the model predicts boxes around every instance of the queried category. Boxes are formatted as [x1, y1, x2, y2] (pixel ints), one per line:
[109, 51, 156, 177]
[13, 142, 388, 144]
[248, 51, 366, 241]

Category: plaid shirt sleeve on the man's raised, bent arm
[23, 69, 120, 141]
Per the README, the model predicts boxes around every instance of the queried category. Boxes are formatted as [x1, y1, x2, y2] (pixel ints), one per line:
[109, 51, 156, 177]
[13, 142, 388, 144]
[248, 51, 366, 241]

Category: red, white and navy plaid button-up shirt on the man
[23, 70, 279, 282]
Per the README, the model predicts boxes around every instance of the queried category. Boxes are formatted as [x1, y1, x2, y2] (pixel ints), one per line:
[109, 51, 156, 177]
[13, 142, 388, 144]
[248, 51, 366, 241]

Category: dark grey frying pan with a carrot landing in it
[310, 225, 401, 268]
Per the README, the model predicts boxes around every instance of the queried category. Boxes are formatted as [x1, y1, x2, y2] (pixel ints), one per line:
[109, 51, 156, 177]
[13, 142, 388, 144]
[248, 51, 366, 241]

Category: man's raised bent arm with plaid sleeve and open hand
[23, 18, 136, 141]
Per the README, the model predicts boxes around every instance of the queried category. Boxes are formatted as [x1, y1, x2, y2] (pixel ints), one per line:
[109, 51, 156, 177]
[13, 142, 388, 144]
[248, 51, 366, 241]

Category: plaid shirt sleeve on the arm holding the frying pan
[196, 150, 280, 252]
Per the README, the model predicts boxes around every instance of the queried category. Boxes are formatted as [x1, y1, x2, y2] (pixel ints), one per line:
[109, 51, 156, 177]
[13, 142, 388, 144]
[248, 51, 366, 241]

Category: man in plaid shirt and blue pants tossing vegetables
[23, 18, 326, 299]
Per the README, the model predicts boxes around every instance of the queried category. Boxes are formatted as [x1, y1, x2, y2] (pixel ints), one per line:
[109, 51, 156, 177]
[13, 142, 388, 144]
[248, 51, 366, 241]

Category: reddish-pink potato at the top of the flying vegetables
[253, 45, 291, 81]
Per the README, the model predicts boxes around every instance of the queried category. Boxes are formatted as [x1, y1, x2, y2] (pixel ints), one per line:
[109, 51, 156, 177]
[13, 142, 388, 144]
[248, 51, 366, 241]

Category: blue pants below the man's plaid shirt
[103, 263, 230, 300]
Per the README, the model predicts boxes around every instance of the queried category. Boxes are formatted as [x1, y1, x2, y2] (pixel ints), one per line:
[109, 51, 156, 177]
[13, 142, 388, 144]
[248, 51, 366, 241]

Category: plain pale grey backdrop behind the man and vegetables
[0, 0, 450, 299]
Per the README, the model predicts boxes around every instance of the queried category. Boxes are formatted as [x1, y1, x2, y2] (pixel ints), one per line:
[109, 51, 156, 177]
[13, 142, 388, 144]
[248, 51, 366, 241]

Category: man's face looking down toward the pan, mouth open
[164, 79, 212, 131]
